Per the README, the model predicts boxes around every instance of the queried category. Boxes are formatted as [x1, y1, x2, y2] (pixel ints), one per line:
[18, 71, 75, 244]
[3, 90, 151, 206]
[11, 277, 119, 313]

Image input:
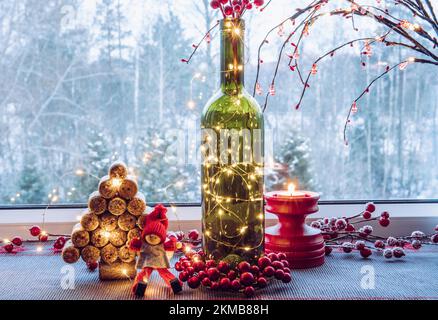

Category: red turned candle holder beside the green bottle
[265, 191, 325, 269]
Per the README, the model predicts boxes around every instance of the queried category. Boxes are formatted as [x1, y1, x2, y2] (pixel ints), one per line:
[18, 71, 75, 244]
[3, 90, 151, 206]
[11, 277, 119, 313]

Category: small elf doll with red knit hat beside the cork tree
[130, 205, 182, 297]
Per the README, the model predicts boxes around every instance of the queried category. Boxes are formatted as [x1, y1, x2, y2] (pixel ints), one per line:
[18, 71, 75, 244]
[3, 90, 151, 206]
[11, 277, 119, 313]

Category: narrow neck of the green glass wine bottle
[220, 19, 245, 95]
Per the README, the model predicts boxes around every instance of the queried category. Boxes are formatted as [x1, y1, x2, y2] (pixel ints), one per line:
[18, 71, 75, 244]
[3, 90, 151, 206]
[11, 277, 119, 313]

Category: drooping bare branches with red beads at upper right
[253, 0, 438, 144]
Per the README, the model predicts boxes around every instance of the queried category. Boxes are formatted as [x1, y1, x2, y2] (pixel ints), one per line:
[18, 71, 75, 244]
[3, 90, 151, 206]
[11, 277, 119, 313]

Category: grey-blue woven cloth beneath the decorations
[0, 245, 438, 300]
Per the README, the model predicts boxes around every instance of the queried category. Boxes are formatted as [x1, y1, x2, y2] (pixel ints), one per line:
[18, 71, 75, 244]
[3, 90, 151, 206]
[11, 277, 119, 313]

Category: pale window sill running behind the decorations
[0, 201, 438, 238]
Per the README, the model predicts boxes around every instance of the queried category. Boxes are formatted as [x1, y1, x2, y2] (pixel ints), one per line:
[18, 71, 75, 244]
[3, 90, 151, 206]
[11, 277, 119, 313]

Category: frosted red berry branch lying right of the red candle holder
[311, 203, 438, 259]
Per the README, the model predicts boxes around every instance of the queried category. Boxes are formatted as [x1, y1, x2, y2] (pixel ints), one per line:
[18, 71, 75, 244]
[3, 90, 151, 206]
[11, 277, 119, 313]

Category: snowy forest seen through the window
[0, 0, 438, 205]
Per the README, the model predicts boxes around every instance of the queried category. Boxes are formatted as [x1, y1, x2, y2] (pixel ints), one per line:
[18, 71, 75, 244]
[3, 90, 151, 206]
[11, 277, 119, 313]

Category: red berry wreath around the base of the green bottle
[175, 251, 292, 297]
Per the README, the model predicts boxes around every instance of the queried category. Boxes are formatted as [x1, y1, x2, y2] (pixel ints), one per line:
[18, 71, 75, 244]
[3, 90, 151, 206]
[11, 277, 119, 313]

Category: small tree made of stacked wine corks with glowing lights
[62, 162, 146, 280]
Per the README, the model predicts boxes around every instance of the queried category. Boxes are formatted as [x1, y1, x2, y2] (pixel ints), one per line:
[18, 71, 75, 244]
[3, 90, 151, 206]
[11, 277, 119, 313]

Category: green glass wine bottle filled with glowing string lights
[201, 19, 265, 261]
